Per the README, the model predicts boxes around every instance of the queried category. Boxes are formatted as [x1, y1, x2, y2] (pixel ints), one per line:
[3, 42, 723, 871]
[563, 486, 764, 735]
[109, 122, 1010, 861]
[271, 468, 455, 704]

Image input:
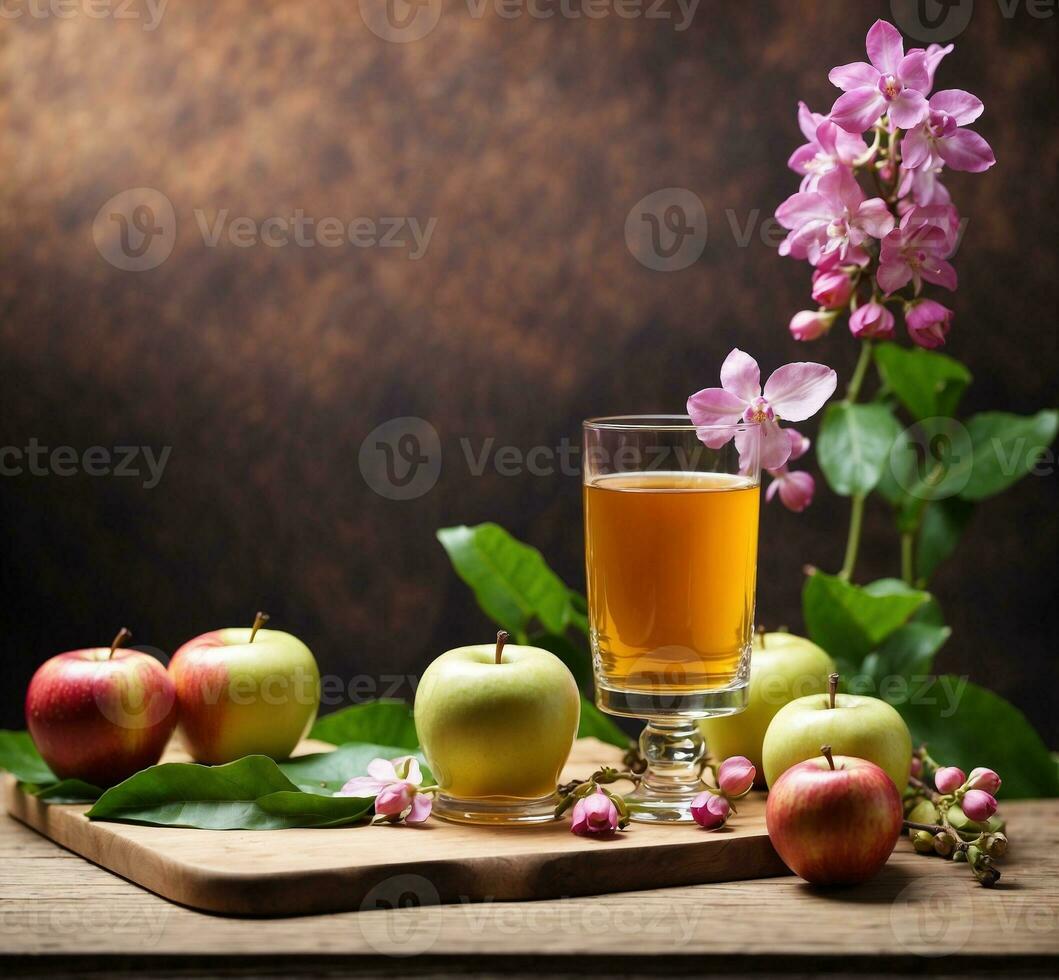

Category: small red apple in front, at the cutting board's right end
[765, 745, 904, 885]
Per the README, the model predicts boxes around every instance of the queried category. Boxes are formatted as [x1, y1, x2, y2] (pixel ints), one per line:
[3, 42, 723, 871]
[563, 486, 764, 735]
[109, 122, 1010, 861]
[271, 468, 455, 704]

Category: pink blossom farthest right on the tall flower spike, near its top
[901, 89, 997, 174]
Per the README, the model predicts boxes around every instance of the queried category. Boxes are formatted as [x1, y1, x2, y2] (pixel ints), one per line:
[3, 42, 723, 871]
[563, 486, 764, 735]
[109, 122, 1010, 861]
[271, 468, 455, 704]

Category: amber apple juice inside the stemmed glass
[585, 473, 759, 695]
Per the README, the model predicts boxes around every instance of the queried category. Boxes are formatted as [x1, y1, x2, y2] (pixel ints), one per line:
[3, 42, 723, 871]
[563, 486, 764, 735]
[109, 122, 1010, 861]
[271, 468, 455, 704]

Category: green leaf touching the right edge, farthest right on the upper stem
[959, 410, 1059, 500]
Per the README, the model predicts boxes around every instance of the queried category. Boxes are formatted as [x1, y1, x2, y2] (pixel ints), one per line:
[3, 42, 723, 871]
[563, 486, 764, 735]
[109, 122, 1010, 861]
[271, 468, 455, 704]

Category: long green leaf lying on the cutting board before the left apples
[87, 755, 374, 831]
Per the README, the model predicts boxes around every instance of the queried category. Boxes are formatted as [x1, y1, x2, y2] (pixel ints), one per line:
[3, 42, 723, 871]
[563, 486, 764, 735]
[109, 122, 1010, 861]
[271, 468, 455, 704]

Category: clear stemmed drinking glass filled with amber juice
[584, 415, 760, 821]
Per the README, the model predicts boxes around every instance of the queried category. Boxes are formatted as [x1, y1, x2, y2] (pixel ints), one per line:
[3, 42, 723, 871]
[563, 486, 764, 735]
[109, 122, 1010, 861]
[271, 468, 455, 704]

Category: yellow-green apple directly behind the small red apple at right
[761, 674, 912, 789]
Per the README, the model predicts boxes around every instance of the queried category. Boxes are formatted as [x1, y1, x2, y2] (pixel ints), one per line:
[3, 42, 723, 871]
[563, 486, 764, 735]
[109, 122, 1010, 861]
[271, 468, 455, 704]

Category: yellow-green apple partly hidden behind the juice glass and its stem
[699, 632, 834, 788]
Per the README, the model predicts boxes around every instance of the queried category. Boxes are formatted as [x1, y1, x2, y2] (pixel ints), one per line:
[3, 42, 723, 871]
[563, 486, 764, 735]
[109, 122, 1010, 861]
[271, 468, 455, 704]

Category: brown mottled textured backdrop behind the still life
[0, 0, 1059, 745]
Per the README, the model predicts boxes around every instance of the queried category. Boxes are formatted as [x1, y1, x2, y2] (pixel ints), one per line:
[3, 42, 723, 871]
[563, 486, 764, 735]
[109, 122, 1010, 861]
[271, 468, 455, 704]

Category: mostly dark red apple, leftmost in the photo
[25, 629, 177, 786]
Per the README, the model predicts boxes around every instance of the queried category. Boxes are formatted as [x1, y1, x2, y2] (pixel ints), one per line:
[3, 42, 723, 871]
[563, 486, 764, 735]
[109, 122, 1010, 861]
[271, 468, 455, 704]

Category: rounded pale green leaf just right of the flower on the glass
[816, 402, 900, 497]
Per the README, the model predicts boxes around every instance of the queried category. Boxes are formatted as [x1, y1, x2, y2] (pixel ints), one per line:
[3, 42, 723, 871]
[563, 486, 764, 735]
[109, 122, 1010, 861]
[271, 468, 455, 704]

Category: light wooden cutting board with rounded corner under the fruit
[4, 738, 787, 915]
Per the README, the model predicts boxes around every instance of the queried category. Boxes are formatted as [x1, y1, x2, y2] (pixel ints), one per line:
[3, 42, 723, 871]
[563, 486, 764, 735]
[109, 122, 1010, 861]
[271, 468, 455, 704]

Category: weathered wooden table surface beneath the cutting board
[0, 801, 1059, 977]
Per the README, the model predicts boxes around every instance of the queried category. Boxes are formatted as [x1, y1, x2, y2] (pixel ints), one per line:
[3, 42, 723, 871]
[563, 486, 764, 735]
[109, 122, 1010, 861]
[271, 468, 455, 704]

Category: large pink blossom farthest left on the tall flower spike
[776, 167, 894, 266]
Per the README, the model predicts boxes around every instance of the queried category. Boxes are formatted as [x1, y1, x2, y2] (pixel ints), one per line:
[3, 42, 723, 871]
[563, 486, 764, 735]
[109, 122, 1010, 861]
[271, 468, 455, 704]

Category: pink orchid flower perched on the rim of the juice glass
[687, 348, 838, 469]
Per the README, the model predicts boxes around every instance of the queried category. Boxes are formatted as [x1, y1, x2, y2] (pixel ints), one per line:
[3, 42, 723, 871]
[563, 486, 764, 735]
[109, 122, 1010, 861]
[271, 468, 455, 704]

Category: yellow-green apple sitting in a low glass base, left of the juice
[415, 632, 581, 800]
